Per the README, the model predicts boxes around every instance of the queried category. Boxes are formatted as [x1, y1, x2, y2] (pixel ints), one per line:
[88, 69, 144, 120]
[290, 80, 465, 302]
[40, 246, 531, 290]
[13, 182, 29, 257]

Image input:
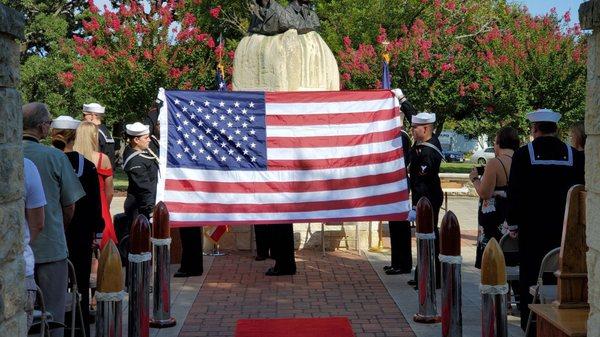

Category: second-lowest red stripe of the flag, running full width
[166, 190, 408, 213]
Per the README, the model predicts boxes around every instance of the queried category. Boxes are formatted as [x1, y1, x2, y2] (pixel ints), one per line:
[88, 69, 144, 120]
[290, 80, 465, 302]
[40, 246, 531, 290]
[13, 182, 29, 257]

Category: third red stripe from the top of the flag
[267, 129, 400, 149]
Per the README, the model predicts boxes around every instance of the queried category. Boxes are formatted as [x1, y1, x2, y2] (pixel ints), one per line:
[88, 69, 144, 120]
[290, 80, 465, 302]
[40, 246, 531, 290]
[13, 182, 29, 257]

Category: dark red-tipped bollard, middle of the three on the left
[127, 215, 152, 337]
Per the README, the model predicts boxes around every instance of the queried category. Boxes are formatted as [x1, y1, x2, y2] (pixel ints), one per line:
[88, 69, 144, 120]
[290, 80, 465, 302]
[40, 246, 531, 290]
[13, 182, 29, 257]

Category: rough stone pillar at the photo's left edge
[0, 4, 27, 337]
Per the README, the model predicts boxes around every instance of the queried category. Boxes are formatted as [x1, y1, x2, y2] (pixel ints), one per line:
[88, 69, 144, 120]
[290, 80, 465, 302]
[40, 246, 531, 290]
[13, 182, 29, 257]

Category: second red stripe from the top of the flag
[267, 108, 400, 126]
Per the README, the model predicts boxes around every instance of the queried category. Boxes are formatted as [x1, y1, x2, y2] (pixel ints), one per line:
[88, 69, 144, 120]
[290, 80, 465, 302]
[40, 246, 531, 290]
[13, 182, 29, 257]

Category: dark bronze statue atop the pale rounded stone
[248, 0, 321, 35]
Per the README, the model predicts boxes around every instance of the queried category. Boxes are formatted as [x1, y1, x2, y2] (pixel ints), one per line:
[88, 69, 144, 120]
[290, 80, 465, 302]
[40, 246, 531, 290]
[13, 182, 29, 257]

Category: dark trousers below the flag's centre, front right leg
[269, 223, 296, 272]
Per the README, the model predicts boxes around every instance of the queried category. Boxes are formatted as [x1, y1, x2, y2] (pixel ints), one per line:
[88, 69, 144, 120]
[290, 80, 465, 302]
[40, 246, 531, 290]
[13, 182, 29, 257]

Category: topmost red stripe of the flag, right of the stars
[265, 90, 394, 104]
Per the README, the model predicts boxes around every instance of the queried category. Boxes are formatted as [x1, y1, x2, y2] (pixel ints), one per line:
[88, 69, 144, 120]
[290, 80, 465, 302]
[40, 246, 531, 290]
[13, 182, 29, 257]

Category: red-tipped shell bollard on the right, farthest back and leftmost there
[413, 197, 441, 323]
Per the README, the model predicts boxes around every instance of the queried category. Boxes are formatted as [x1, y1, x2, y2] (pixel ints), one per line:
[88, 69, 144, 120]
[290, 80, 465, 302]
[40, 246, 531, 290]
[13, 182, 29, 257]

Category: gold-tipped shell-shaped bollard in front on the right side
[479, 238, 508, 337]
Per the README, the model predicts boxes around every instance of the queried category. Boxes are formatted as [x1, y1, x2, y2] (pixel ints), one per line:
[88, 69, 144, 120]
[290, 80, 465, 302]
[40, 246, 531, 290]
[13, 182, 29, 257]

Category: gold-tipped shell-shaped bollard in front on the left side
[96, 240, 125, 337]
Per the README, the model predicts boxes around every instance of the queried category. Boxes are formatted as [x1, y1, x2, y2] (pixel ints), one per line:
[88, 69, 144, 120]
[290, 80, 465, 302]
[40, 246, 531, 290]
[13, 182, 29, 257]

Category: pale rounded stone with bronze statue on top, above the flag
[232, 0, 340, 91]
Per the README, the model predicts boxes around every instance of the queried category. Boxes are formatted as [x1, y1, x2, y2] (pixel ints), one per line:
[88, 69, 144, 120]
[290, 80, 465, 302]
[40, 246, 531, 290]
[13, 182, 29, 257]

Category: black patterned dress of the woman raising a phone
[475, 159, 508, 269]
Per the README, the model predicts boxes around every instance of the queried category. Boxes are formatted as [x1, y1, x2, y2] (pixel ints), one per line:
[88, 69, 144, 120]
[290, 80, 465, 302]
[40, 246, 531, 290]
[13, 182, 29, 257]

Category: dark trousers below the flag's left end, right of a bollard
[179, 227, 204, 274]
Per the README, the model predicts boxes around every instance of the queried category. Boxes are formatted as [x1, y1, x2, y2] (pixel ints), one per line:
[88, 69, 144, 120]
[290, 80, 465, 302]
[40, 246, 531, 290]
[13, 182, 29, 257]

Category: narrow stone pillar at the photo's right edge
[579, 0, 600, 336]
